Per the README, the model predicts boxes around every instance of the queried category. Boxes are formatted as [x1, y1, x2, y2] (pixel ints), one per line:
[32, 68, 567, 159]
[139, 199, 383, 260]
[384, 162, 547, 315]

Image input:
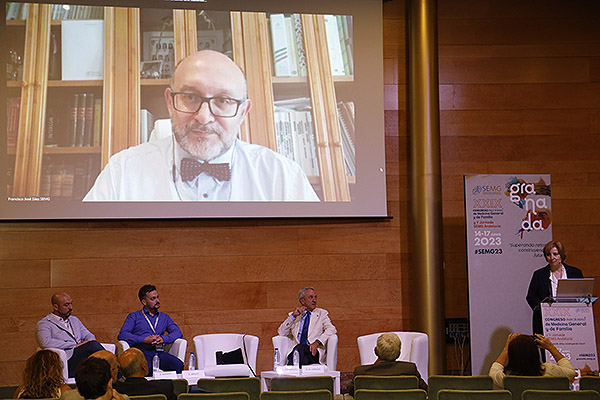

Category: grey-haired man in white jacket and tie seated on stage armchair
[277, 287, 337, 365]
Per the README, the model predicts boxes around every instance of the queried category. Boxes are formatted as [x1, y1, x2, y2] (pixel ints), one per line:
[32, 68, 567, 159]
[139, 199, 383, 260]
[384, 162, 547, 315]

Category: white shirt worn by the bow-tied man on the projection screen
[83, 136, 319, 201]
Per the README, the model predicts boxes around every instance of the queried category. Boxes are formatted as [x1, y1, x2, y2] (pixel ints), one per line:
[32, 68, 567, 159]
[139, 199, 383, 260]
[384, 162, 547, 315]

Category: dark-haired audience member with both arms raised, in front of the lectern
[490, 333, 576, 389]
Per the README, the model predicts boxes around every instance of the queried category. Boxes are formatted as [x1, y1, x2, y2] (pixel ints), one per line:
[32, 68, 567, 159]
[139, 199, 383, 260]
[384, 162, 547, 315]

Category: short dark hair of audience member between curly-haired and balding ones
[75, 357, 112, 399]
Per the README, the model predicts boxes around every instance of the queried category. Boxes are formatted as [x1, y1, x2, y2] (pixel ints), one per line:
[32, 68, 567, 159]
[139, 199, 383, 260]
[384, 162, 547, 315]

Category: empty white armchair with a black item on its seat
[194, 333, 258, 377]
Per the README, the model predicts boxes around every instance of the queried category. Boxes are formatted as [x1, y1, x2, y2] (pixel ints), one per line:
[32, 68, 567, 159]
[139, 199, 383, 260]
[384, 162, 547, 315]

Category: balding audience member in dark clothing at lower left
[113, 347, 176, 400]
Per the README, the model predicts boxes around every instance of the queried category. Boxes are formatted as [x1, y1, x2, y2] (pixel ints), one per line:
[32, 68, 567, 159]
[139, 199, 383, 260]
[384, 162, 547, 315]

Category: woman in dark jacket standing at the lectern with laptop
[526, 240, 583, 334]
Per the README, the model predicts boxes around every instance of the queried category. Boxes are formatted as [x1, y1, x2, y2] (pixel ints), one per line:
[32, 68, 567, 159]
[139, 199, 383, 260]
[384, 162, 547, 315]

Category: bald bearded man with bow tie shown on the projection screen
[83, 50, 319, 201]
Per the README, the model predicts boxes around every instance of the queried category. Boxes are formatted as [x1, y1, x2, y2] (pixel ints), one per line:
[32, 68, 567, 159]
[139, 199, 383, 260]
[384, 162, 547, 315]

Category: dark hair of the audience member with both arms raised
[504, 335, 544, 376]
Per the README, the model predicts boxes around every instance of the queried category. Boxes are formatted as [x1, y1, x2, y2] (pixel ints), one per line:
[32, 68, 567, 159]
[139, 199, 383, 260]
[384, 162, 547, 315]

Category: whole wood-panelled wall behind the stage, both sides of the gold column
[0, 0, 600, 384]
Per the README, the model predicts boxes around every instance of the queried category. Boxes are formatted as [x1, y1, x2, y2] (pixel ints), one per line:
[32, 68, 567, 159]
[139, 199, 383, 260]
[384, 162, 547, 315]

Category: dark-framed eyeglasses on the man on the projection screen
[171, 91, 247, 118]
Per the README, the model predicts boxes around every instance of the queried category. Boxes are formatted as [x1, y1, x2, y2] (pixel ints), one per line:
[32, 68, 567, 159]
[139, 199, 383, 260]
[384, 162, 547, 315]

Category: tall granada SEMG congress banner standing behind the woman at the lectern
[464, 174, 552, 375]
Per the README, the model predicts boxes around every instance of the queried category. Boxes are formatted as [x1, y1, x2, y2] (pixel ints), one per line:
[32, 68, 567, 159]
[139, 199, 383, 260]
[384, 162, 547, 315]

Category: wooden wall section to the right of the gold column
[439, 0, 600, 372]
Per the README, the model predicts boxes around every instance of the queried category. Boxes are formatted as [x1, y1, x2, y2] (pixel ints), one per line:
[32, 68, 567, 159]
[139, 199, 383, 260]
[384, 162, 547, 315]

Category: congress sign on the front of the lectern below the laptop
[542, 303, 598, 376]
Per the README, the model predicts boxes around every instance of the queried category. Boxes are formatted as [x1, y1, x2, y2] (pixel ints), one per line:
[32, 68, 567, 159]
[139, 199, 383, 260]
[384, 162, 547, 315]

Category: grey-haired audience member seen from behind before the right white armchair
[348, 333, 427, 396]
